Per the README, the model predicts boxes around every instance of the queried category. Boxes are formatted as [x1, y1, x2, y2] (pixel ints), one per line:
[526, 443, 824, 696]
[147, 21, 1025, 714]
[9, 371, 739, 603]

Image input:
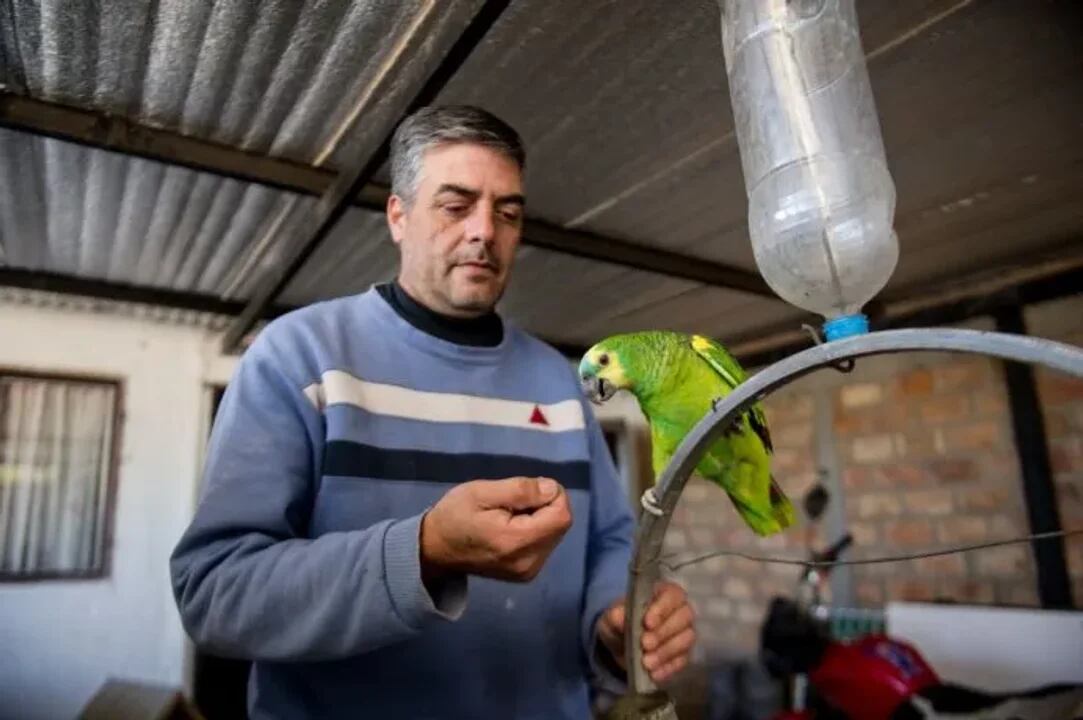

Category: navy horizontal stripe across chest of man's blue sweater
[323, 440, 590, 490]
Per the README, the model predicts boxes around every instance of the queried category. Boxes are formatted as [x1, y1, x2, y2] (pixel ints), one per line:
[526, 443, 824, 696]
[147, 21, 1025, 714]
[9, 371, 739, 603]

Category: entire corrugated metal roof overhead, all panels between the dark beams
[0, 0, 1083, 348]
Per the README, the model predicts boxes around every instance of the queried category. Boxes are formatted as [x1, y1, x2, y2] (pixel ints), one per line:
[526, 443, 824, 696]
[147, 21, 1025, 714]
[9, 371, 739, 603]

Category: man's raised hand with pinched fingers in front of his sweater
[421, 477, 572, 585]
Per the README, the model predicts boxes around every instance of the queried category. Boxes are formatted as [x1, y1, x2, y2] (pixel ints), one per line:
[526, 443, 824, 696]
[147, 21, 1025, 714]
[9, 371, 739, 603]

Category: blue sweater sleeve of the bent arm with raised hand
[170, 327, 467, 660]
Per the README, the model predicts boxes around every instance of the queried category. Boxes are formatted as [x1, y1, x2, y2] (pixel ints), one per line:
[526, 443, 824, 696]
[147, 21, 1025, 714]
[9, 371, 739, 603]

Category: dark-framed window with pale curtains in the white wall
[0, 371, 120, 580]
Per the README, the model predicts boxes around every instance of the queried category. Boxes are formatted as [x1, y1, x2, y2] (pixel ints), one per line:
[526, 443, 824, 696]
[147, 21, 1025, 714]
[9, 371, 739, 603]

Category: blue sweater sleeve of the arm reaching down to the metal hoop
[582, 400, 636, 694]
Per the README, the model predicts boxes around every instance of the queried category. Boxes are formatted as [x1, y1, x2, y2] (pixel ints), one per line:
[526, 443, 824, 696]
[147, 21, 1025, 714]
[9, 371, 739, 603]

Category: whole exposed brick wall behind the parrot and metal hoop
[666, 300, 1083, 659]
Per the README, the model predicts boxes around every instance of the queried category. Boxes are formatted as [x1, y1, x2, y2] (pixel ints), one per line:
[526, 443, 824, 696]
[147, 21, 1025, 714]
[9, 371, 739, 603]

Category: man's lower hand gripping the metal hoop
[598, 581, 695, 684]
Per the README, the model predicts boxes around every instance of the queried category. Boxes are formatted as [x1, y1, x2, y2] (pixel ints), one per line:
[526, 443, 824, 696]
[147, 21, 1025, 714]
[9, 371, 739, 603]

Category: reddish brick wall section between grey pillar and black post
[834, 356, 1036, 605]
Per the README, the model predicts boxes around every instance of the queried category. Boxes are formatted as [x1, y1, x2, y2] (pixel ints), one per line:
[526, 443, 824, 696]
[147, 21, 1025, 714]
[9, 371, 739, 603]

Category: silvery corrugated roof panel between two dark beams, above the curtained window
[0, 129, 314, 296]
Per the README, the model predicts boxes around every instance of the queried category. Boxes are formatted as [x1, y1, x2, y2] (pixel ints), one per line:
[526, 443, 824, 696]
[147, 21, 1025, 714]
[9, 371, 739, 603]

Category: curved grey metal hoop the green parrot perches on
[625, 328, 1083, 720]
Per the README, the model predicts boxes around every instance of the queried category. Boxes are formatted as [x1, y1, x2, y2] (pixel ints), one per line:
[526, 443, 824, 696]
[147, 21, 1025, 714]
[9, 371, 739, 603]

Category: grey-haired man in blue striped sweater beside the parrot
[171, 107, 694, 720]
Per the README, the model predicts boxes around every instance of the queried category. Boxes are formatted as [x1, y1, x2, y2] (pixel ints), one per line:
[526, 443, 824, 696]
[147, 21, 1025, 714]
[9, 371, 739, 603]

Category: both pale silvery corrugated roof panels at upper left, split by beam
[0, 0, 479, 301]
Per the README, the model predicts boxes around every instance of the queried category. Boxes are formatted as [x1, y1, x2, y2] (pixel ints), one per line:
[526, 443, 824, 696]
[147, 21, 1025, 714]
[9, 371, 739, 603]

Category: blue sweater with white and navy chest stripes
[170, 289, 634, 720]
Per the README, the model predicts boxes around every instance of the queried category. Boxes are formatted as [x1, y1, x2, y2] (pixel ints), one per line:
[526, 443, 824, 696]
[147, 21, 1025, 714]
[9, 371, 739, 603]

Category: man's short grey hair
[391, 105, 526, 204]
